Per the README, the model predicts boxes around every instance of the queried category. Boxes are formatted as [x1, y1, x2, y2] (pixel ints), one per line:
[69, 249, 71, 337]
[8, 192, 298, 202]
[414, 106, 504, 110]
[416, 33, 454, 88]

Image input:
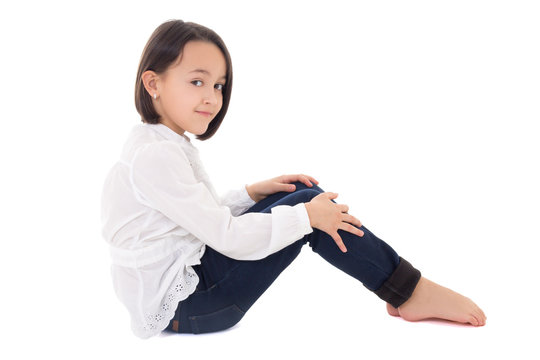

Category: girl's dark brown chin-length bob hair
[135, 20, 233, 140]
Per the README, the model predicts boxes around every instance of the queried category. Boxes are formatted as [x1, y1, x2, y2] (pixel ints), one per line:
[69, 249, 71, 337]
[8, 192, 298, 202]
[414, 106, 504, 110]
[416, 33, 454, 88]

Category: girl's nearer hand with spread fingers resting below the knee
[306, 192, 364, 252]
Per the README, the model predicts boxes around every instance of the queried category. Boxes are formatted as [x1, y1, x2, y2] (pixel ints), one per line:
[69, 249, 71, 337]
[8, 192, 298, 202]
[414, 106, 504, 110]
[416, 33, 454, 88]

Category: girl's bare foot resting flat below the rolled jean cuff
[387, 277, 486, 326]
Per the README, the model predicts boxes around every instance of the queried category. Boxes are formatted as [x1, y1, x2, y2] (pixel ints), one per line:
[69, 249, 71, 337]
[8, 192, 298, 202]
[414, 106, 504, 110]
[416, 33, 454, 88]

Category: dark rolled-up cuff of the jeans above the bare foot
[374, 257, 421, 308]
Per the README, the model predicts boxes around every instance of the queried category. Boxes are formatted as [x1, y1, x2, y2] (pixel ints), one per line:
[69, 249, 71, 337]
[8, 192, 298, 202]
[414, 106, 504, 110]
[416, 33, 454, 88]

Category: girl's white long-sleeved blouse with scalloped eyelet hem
[102, 124, 313, 338]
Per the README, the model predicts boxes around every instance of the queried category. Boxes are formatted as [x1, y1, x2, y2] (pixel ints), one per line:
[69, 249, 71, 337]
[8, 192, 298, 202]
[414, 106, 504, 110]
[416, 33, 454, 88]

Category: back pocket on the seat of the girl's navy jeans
[189, 305, 245, 334]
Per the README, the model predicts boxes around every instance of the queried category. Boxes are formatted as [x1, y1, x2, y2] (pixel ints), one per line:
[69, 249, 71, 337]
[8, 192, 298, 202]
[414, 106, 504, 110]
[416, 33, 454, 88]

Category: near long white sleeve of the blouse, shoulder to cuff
[130, 141, 313, 260]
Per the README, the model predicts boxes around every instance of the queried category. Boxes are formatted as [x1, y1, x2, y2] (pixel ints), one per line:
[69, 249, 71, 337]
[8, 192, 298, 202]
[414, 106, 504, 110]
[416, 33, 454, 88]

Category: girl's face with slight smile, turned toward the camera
[152, 41, 227, 135]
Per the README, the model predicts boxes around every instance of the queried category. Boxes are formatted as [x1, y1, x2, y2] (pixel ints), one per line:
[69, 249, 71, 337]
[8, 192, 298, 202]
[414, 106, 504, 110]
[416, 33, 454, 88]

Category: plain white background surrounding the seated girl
[0, 0, 540, 359]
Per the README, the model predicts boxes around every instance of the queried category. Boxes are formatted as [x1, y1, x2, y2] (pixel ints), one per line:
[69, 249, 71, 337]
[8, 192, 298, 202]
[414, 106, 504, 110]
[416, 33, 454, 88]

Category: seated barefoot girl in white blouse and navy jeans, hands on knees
[102, 20, 486, 338]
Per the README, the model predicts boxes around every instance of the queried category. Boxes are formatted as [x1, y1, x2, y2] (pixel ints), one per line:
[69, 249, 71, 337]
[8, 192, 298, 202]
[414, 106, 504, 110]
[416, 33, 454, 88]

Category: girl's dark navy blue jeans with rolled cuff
[167, 182, 420, 334]
